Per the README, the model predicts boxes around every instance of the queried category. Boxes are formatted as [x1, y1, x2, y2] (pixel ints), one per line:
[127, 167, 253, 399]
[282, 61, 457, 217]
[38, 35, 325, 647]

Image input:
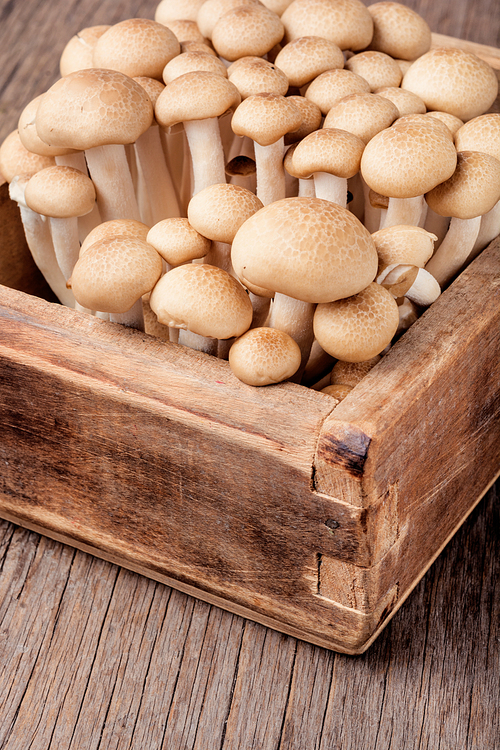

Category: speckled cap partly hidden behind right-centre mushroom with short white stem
[323, 94, 399, 143]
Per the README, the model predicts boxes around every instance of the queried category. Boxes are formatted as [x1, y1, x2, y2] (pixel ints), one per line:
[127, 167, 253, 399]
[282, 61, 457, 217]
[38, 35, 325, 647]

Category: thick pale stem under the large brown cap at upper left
[85, 144, 141, 222]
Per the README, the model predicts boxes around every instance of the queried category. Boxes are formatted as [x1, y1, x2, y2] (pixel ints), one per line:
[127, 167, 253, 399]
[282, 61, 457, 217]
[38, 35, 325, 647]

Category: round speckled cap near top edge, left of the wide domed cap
[212, 5, 285, 61]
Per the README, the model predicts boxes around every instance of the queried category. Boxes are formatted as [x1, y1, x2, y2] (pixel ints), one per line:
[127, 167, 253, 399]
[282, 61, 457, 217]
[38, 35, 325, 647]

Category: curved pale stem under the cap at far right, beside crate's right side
[425, 216, 481, 287]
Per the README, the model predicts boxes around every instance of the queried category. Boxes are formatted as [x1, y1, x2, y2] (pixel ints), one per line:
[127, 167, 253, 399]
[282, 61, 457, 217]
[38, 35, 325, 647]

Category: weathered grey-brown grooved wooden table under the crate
[0, 0, 500, 750]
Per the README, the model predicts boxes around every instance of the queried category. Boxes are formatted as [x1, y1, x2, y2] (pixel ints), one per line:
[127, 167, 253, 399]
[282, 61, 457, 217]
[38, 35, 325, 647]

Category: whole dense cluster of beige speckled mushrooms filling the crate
[0, 0, 500, 394]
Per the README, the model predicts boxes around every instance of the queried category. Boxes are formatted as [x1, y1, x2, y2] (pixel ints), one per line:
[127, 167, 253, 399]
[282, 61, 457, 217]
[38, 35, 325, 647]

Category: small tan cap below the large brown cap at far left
[24, 165, 96, 219]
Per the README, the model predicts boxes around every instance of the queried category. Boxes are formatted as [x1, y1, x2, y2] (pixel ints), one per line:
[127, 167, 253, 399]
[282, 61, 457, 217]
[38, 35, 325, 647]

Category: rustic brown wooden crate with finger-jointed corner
[0, 38, 500, 654]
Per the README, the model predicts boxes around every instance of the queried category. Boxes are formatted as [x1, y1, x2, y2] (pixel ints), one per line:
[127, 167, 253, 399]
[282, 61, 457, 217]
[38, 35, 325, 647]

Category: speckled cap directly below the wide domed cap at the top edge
[274, 36, 344, 88]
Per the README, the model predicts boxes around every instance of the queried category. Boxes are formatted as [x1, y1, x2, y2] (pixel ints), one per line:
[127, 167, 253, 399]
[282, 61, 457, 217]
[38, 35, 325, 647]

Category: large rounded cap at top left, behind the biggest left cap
[92, 18, 181, 80]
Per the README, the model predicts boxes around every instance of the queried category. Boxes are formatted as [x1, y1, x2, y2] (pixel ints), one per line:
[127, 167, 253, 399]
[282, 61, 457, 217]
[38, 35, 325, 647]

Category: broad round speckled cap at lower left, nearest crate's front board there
[70, 237, 162, 313]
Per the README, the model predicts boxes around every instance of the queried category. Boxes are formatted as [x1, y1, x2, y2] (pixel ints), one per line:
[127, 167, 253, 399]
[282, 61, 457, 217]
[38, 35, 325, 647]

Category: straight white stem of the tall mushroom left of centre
[184, 117, 226, 195]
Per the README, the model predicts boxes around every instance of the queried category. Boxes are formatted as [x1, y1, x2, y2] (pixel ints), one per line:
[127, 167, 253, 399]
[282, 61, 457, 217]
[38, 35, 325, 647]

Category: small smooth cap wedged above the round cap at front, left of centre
[146, 216, 212, 266]
